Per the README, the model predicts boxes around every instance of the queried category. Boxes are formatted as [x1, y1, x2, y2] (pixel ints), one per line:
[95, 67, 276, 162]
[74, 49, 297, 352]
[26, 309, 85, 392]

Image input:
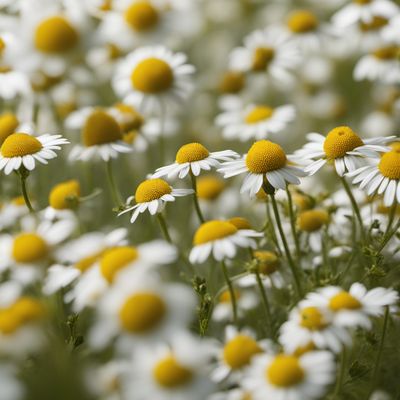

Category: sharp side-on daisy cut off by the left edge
[0, 132, 69, 175]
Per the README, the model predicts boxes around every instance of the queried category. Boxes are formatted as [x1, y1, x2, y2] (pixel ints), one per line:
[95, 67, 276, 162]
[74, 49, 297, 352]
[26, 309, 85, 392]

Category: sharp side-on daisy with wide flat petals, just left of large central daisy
[153, 142, 239, 179]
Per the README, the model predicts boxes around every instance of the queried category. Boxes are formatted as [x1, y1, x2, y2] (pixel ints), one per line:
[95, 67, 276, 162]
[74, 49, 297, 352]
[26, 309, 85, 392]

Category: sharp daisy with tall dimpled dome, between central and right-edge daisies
[292, 126, 393, 176]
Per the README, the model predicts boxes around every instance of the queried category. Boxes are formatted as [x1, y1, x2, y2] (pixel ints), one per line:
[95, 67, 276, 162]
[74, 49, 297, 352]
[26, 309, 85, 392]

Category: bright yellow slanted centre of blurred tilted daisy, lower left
[100, 246, 138, 283]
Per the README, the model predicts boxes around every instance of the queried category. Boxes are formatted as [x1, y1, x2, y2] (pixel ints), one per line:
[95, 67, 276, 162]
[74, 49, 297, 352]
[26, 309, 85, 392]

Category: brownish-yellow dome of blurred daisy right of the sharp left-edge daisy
[82, 110, 122, 147]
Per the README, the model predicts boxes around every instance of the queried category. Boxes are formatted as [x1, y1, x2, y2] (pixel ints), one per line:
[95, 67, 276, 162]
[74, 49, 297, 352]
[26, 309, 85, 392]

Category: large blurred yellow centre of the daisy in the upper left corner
[34, 16, 79, 54]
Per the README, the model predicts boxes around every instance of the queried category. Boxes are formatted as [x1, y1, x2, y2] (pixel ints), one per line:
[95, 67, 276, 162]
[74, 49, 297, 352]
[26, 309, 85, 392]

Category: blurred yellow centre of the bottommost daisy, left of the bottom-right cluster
[153, 355, 193, 389]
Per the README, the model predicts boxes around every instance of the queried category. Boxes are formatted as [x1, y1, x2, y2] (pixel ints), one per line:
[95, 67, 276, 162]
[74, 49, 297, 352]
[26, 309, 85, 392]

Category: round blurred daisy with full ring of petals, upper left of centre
[113, 46, 195, 114]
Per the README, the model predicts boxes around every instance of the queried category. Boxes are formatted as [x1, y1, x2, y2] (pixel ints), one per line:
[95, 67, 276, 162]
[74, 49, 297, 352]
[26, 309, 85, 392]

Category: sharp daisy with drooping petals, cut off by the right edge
[348, 148, 400, 207]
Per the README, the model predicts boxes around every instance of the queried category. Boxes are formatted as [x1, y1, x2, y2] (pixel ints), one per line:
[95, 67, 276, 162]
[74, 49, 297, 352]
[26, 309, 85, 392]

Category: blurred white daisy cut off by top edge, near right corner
[332, 0, 398, 28]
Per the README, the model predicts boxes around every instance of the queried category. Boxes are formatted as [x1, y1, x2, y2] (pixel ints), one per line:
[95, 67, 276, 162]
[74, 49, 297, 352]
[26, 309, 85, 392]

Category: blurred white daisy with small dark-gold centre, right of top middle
[229, 27, 300, 84]
